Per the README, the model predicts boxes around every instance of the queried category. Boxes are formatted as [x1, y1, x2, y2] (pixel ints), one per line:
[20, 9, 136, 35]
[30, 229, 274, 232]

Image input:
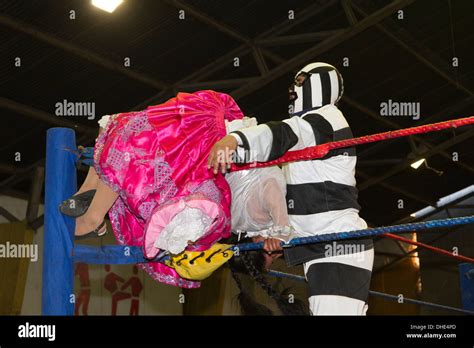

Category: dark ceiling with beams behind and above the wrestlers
[0, 0, 474, 225]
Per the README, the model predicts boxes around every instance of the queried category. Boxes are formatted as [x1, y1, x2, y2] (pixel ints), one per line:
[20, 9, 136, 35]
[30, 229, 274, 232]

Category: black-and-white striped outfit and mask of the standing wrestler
[233, 63, 373, 315]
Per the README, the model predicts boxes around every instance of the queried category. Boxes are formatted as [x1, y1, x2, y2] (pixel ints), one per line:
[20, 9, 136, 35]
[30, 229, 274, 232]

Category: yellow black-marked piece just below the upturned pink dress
[165, 243, 234, 280]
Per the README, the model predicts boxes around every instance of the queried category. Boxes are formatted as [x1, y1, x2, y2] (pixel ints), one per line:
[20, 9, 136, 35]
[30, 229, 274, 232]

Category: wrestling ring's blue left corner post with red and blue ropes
[42, 116, 474, 315]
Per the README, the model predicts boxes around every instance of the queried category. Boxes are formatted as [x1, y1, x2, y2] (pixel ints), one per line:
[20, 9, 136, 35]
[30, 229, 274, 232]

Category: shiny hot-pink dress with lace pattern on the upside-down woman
[94, 91, 243, 288]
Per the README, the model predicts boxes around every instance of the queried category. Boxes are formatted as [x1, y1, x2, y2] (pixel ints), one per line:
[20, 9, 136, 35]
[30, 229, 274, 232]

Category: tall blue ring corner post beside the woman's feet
[42, 128, 77, 315]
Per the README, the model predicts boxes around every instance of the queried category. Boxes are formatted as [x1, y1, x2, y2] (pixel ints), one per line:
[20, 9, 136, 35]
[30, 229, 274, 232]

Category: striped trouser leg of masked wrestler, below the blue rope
[303, 248, 374, 315]
